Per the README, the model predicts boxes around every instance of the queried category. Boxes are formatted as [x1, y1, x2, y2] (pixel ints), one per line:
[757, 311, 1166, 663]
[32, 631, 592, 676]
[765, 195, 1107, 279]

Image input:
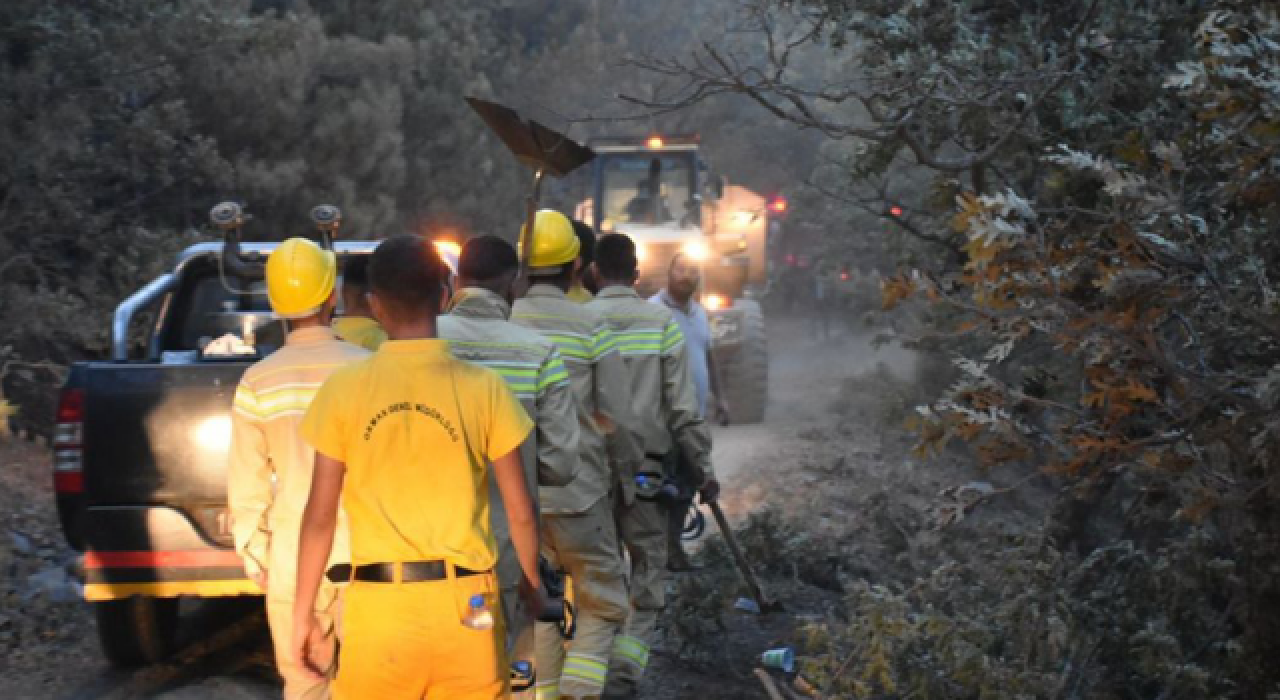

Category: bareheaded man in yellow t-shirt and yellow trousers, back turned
[293, 235, 543, 700]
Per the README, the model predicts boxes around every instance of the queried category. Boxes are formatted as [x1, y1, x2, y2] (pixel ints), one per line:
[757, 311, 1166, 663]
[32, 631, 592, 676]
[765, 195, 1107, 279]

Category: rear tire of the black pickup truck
[93, 595, 178, 668]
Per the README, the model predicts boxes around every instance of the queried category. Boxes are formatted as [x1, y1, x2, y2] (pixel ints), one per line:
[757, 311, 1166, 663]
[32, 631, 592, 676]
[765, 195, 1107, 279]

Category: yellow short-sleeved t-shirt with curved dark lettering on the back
[300, 339, 532, 571]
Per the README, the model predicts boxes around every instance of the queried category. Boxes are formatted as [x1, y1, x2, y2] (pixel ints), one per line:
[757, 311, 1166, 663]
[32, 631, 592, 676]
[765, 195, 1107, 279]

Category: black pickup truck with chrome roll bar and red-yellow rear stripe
[54, 229, 375, 665]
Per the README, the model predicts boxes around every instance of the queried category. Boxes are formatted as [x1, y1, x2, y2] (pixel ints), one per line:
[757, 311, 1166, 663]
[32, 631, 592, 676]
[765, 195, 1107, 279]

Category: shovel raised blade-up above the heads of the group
[467, 97, 595, 279]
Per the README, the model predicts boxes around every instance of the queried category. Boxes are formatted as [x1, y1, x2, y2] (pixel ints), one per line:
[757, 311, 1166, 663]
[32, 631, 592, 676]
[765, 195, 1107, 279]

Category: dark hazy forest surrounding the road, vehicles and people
[0, 0, 1280, 699]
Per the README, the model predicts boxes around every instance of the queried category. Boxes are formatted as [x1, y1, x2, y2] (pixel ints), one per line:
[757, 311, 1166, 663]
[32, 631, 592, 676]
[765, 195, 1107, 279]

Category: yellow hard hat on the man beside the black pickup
[266, 238, 338, 319]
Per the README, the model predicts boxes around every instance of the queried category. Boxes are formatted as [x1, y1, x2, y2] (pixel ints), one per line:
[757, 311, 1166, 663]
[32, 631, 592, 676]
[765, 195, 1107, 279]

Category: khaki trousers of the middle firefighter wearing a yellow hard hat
[535, 498, 628, 700]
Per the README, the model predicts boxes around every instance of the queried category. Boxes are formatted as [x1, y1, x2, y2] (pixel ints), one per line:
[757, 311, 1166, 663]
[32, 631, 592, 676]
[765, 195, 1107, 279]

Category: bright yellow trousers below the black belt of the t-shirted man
[334, 573, 511, 700]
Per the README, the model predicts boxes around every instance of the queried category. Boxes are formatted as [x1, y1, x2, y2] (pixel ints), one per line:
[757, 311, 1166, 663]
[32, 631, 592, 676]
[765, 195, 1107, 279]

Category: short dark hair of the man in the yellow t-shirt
[369, 234, 449, 319]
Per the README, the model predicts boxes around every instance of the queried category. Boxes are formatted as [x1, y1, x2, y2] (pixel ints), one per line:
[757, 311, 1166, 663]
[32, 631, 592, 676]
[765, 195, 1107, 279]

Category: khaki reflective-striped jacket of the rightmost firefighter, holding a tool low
[586, 285, 713, 480]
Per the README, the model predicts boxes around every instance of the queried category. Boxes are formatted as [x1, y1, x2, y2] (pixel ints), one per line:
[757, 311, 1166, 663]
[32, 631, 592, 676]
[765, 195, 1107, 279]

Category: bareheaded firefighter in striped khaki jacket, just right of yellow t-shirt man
[439, 235, 579, 696]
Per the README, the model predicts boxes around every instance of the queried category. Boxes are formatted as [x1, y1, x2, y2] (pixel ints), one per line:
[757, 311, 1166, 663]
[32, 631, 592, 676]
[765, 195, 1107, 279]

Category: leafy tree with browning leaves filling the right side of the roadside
[627, 0, 1280, 697]
